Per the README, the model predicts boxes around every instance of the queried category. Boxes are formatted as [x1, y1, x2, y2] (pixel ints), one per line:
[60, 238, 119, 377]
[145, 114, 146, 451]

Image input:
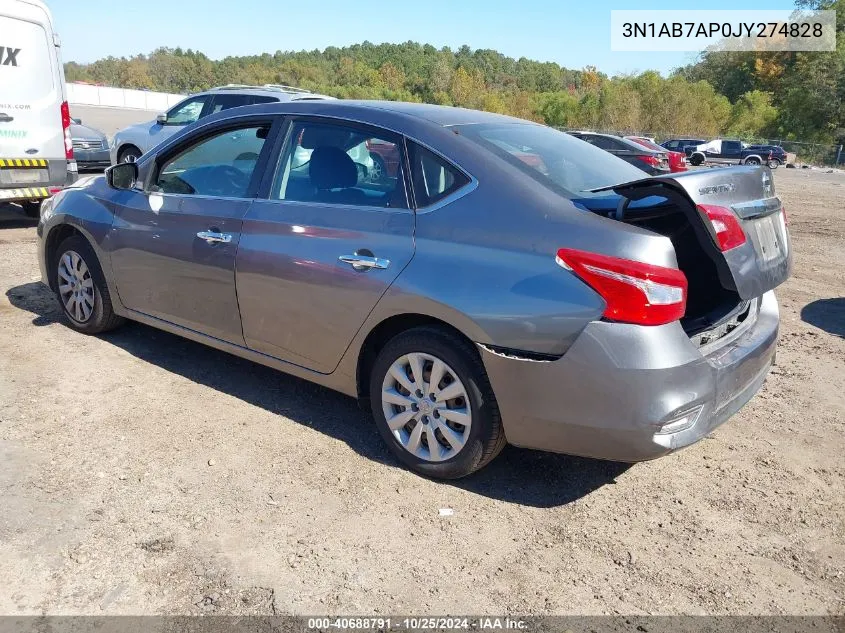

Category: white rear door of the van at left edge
[0, 0, 66, 173]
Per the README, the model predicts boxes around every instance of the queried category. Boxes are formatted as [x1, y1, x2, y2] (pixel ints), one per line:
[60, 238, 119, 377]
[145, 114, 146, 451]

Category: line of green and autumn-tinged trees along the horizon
[65, 0, 845, 143]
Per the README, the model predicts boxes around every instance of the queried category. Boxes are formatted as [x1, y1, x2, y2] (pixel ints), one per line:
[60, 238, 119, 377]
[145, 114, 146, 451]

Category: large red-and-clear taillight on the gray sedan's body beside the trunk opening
[555, 248, 687, 325]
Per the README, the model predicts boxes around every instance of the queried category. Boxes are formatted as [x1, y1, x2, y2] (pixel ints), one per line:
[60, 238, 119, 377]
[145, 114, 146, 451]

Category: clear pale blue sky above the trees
[47, 0, 794, 75]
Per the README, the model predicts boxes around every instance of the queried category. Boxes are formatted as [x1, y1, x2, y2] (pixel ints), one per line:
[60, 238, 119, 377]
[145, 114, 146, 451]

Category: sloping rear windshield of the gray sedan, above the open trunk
[458, 123, 647, 198]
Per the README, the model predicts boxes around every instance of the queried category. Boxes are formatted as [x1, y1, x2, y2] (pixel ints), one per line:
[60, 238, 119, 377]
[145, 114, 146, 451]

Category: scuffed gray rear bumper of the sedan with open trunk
[481, 292, 779, 462]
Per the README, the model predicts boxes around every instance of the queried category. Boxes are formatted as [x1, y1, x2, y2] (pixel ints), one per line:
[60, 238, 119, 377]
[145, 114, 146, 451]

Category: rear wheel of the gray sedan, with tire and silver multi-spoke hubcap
[370, 327, 506, 479]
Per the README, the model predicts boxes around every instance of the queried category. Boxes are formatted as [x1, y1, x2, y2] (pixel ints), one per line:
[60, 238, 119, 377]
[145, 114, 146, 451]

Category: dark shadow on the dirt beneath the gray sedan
[6, 282, 630, 507]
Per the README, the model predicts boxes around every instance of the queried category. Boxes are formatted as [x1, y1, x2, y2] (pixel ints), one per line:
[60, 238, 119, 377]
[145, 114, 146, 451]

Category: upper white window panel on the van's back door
[0, 16, 58, 101]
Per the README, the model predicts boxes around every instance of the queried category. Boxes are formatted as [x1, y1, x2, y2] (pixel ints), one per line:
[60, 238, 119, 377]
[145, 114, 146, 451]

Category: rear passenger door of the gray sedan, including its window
[236, 119, 414, 373]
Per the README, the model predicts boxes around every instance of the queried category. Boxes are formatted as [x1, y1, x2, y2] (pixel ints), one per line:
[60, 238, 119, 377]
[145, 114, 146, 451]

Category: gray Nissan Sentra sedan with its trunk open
[38, 101, 791, 478]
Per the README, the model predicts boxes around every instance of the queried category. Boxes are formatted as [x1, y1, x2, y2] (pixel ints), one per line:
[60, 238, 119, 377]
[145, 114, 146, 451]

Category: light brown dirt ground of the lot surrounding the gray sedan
[0, 169, 845, 615]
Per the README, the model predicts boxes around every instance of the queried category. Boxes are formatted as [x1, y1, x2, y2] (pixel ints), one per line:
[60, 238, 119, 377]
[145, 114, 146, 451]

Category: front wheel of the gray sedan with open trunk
[51, 235, 123, 334]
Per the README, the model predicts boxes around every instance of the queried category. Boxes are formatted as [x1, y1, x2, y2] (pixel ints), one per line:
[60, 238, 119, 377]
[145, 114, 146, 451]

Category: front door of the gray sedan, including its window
[110, 119, 271, 345]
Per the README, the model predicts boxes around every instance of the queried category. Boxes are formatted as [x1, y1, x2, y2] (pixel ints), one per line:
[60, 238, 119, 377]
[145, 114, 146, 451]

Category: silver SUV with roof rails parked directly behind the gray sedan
[110, 84, 333, 165]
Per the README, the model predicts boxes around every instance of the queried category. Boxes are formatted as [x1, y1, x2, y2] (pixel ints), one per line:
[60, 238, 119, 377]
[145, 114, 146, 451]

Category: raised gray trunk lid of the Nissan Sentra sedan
[580, 166, 792, 300]
